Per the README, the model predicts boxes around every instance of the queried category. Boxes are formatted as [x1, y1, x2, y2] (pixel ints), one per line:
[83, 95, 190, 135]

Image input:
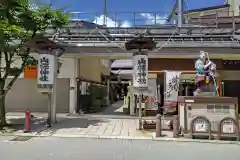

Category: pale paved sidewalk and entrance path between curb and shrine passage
[3, 101, 172, 139]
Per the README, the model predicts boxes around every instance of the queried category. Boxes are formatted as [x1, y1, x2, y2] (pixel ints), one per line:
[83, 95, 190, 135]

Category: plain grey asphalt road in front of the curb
[0, 137, 240, 160]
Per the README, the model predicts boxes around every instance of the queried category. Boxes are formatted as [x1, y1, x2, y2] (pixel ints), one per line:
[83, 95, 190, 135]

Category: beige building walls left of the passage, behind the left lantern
[2, 54, 110, 113]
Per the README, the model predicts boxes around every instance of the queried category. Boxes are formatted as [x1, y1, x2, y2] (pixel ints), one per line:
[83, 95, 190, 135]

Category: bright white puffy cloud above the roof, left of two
[93, 15, 132, 27]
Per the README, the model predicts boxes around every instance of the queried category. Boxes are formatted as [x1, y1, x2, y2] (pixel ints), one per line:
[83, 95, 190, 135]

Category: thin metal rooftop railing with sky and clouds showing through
[68, 10, 240, 28]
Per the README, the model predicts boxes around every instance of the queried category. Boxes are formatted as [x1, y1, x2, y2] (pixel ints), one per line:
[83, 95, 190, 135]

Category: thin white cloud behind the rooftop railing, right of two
[140, 13, 166, 25]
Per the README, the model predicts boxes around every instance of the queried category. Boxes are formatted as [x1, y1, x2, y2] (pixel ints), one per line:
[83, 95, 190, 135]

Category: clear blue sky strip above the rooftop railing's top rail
[52, 0, 224, 12]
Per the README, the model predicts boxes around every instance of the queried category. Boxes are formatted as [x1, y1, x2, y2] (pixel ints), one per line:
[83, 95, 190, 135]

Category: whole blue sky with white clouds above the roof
[35, 0, 224, 26]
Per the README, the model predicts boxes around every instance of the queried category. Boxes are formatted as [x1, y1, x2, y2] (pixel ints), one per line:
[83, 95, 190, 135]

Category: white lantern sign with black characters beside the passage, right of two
[133, 55, 148, 88]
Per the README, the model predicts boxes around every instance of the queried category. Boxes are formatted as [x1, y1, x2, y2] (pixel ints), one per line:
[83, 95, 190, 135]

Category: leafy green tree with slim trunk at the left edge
[0, 0, 69, 126]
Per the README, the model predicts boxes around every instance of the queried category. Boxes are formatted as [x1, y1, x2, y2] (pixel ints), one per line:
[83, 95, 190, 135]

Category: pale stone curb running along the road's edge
[0, 133, 240, 145]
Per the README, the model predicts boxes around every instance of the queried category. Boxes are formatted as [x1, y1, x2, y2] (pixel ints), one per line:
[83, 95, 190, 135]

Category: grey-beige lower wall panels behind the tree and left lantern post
[6, 78, 69, 113]
